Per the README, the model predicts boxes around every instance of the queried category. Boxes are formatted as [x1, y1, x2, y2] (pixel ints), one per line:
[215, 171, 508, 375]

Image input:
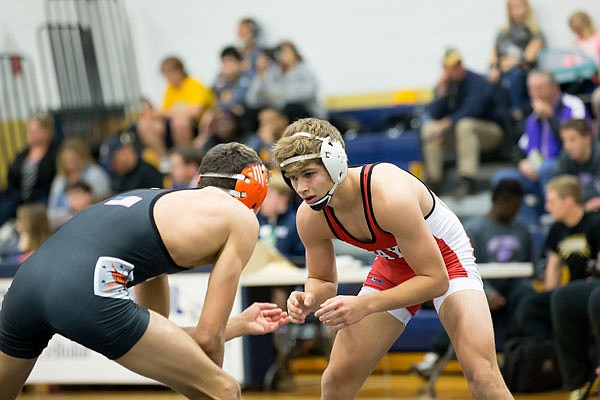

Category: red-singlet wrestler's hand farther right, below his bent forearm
[315, 296, 370, 331]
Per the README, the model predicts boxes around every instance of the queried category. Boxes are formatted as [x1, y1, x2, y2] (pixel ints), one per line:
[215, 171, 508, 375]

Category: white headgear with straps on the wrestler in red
[279, 132, 348, 211]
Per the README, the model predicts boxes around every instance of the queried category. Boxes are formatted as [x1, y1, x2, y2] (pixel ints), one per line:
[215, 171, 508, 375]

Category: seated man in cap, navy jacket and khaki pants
[421, 49, 504, 196]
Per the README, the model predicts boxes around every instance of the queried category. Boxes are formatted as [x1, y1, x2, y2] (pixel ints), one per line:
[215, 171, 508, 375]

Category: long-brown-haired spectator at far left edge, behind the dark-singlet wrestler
[0, 203, 50, 264]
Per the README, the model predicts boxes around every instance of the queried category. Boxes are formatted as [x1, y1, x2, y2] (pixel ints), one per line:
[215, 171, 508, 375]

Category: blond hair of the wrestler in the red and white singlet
[273, 118, 345, 176]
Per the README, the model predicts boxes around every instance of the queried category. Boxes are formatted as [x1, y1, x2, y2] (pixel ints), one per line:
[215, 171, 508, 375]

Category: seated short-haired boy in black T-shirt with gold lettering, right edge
[516, 175, 600, 340]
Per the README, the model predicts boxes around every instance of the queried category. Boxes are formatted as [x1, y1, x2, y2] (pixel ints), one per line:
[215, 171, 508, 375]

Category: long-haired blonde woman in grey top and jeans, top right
[488, 0, 545, 121]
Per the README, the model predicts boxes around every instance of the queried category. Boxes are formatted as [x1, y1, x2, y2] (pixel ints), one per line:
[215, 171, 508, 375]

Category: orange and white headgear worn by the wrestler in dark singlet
[198, 164, 269, 213]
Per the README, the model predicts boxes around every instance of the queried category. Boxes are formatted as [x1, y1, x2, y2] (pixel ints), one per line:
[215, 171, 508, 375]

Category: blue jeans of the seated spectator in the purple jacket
[492, 159, 557, 225]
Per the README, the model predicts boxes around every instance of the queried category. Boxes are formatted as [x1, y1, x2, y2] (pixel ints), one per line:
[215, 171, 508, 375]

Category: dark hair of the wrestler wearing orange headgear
[198, 142, 262, 189]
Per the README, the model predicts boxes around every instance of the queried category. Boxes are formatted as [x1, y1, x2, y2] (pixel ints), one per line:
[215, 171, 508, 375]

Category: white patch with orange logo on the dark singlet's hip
[94, 257, 134, 299]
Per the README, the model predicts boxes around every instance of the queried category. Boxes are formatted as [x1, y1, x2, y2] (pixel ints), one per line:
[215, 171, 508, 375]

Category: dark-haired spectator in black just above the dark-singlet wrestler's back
[100, 132, 163, 193]
